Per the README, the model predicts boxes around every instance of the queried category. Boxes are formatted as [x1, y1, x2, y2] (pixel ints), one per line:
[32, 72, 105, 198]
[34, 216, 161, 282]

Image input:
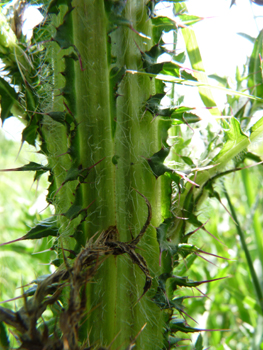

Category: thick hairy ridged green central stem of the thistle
[72, 0, 163, 349]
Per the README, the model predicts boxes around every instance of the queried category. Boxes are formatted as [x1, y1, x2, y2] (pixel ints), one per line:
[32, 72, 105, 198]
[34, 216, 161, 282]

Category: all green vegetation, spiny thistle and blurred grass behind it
[0, 0, 263, 350]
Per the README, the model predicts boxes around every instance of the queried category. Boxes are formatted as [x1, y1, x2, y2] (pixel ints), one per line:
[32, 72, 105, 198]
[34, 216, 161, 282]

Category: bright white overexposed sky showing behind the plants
[3, 0, 263, 141]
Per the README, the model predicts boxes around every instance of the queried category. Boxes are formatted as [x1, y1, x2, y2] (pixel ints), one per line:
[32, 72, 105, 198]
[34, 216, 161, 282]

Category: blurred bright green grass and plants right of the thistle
[171, 15, 263, 350]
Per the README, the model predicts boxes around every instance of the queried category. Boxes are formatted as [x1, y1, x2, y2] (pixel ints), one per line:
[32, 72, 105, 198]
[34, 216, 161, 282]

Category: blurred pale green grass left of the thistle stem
[0, 129, 52, 307]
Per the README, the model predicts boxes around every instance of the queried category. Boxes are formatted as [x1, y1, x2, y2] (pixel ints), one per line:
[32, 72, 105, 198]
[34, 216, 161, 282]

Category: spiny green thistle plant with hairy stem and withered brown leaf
[0, 0, 262, 349]
